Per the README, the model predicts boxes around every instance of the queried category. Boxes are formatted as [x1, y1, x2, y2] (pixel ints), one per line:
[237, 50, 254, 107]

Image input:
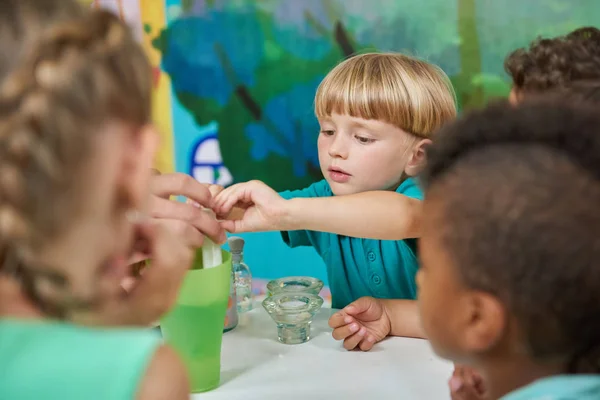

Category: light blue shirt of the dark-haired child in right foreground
[501, 375, 600, 400]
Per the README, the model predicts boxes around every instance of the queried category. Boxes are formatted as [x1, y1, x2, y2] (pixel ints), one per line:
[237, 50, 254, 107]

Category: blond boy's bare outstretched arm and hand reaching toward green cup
[213, 181, 421, 240]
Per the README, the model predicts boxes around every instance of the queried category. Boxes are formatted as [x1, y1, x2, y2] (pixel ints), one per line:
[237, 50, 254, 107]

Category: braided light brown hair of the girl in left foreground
[0, 11, 151, 317]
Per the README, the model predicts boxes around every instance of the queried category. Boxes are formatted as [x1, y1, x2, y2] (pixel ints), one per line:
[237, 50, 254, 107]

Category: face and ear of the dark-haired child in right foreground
[417, 191, 506, 365]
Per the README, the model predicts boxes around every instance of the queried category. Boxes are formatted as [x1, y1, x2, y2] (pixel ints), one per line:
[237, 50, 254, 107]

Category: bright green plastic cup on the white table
[160, 249, 231, 393]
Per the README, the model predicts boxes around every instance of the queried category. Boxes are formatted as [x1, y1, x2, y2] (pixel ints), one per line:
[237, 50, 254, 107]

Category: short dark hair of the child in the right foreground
[423, 100, 600, 373]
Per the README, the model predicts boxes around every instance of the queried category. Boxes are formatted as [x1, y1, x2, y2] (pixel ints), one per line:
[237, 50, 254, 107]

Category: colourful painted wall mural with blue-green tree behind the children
[88, 0, 600, 290]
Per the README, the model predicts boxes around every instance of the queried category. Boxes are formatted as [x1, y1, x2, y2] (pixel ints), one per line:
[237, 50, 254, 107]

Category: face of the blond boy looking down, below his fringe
[318, 114, 429, 195]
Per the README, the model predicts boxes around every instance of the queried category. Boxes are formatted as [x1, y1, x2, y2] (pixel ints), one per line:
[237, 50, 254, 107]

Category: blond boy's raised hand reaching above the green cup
[212, 181, 287, 233]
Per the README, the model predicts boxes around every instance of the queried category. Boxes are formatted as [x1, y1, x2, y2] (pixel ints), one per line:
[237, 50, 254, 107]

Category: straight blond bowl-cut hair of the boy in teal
[315, 53, 456, 138]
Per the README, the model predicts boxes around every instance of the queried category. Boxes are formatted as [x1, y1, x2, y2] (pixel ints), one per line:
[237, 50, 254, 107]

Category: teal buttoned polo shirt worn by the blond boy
[280, 178, 423, 308]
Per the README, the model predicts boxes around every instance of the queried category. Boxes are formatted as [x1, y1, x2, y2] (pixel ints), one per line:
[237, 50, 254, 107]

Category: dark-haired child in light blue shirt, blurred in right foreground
[417, 97, 600, 400]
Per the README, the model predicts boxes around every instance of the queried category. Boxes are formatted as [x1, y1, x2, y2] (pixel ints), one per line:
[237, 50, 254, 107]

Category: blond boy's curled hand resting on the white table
[329, 297, 391, 351]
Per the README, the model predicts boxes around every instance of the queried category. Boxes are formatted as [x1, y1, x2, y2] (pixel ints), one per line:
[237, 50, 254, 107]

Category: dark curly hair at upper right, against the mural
[504, 27, 600, 92]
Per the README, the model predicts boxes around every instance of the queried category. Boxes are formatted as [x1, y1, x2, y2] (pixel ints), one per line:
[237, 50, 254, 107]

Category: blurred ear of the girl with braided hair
[120, 125, 159, 210]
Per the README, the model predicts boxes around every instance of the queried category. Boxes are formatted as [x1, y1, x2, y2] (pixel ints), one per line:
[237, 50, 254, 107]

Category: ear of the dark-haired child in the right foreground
[461, 291, 508, 354]
